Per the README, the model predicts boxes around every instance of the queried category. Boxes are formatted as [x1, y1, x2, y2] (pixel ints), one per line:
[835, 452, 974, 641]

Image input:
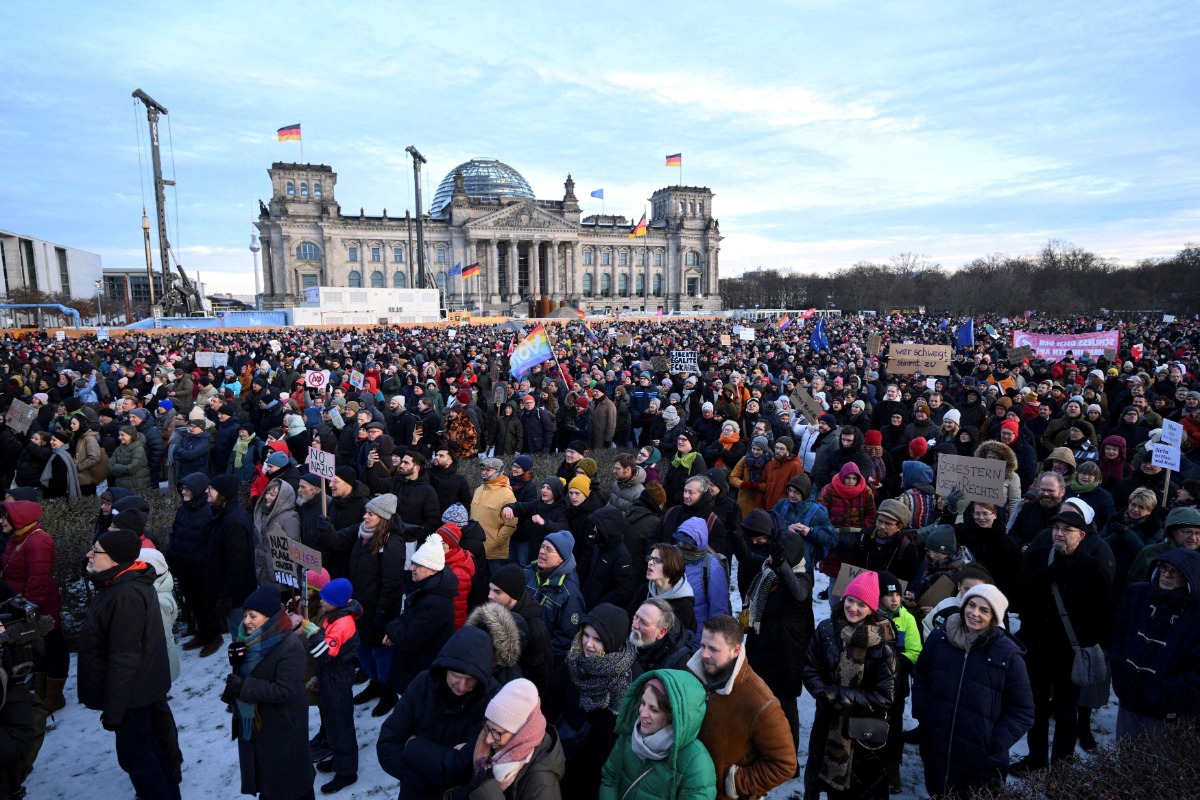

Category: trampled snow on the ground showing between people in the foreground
[25, 573, 1116, 800]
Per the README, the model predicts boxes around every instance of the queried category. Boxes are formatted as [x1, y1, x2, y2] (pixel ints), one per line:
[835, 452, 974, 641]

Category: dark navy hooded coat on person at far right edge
[1109, 547, 1200, 718]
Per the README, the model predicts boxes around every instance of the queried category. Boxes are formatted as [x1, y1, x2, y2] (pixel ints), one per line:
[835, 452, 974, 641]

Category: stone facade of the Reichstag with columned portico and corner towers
[256, 162, 721, 314]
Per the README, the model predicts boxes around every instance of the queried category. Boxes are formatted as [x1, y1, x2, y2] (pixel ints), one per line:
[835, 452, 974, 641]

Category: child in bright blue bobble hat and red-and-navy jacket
[301, 578, 362, 794]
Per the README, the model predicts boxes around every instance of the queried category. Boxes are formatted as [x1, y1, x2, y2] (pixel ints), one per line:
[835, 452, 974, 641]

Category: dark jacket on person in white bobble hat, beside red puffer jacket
[383, 569, 458, 694]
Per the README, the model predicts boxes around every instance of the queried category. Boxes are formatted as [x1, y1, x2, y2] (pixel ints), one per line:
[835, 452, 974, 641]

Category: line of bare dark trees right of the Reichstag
[721, 241, 1200, 315]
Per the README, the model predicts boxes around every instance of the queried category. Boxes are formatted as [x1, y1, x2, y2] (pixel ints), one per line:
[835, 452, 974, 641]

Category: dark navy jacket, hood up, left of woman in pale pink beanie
[376, 625, 499, 800]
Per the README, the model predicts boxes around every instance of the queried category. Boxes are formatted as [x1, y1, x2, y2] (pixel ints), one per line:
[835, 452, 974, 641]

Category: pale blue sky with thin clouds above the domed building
[0, 0, 1200, 294]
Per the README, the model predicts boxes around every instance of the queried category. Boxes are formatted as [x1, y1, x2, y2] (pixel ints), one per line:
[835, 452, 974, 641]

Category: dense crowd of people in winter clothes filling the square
[0, 314, 1200, 800]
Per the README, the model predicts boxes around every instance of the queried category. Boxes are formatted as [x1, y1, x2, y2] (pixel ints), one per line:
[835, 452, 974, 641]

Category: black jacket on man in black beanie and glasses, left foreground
[78, 561, 171, 726]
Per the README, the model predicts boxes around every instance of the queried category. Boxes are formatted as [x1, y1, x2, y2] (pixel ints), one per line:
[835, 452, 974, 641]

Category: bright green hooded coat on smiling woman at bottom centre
[600, 669, 716, 800]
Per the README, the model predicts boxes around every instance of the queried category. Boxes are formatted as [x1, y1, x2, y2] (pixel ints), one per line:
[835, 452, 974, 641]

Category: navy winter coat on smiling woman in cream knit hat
[912, 618, 1033, 795]
